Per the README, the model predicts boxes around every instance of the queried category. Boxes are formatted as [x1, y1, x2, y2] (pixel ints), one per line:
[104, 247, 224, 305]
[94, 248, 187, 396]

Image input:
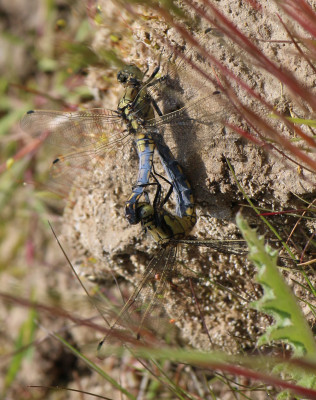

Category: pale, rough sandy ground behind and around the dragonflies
[64, 1, 315, 352]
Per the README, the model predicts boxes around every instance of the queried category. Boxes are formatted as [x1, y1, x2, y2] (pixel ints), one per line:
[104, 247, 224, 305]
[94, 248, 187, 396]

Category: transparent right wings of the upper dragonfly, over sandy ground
[141, 35, 233, 158]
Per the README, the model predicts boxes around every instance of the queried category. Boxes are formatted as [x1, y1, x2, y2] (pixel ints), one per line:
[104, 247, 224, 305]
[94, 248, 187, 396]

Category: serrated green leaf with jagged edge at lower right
[236, 214, 316, 357]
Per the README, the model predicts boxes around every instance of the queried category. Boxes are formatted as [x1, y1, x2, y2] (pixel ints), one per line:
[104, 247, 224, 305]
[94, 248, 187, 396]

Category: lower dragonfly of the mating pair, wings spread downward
[98, 160, 253, 351]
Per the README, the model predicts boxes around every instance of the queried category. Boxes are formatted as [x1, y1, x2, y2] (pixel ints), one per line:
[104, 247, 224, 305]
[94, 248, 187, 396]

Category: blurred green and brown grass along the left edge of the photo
[0, 0, 97, 399]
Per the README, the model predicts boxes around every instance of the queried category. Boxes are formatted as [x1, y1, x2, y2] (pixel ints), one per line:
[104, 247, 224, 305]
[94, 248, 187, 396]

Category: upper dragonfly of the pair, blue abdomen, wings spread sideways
[21, 40, 227, 224]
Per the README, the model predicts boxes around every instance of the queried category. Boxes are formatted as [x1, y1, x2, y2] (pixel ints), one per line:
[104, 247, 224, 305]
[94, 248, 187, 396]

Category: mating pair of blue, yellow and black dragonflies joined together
[21, 43, 236, 344]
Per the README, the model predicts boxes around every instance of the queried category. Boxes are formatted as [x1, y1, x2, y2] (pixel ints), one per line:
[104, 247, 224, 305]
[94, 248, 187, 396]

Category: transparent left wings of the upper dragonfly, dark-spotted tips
[21, 109, 129, 196]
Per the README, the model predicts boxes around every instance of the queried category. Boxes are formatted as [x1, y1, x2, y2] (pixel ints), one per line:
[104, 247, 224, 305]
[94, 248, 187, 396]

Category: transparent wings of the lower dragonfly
[105, 240, 252, 340]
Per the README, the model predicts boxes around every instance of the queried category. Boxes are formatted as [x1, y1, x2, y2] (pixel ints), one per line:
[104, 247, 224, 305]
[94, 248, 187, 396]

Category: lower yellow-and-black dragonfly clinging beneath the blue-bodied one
[99, 165, 253, 348]
